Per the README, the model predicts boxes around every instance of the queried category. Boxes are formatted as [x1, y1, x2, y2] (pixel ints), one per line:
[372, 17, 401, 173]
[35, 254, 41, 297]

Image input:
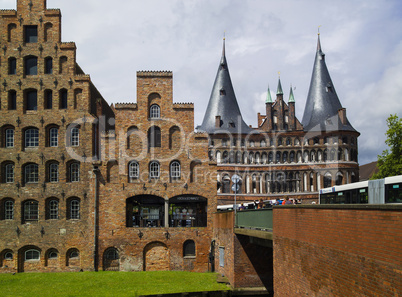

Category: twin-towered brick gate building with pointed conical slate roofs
[197, 37, 359, 204]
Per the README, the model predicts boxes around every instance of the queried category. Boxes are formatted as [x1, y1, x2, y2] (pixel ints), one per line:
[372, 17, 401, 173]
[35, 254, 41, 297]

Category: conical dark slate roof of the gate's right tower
[302, 35, 356, 131]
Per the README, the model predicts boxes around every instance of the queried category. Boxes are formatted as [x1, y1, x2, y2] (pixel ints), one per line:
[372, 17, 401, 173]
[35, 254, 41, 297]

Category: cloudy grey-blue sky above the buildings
[0, 0, 402, 164]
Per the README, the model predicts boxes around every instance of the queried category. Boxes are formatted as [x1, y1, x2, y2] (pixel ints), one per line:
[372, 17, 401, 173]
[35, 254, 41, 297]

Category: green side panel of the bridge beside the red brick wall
[235, 208, 273, 232]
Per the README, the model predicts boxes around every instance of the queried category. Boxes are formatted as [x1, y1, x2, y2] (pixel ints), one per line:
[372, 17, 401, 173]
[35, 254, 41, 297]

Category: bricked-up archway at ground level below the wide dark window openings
[144, 242, 170, 271]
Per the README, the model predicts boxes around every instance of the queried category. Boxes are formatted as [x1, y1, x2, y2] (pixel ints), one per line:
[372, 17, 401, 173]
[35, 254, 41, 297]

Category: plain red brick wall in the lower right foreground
[274, 205, 402, 297]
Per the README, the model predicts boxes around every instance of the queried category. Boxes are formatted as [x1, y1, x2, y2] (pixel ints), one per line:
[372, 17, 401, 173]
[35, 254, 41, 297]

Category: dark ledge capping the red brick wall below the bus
[273, 203, 402, 211]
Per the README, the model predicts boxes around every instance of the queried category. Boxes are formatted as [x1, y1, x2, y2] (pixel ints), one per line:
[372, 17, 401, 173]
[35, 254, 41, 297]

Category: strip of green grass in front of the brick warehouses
[0, 271, 228, 297]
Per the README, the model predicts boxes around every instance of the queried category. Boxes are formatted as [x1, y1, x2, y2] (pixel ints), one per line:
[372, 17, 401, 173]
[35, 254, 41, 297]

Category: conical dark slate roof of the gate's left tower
[197, 40, 253, 134]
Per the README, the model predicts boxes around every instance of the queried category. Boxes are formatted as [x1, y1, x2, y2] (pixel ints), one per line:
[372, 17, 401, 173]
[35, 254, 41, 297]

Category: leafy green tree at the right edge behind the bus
[372, 114, 402, 179]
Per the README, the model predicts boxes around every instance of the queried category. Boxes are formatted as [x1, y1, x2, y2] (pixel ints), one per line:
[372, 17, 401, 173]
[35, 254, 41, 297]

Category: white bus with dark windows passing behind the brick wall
[319, 175, 402, 204]
